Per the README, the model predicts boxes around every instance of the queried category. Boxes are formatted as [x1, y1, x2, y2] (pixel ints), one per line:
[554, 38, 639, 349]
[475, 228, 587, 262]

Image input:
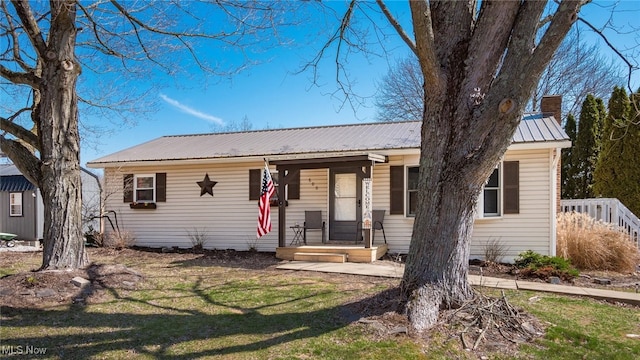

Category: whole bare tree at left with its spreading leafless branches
[0, 0, 292, 269]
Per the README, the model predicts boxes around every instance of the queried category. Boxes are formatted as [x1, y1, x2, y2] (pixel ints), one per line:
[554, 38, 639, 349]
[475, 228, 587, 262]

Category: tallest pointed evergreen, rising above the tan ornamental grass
[594, 86, 631, 203]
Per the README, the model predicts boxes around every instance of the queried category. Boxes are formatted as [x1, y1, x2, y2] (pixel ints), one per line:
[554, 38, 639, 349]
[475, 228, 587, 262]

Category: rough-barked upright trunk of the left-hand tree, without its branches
[35, 1, 88, 269]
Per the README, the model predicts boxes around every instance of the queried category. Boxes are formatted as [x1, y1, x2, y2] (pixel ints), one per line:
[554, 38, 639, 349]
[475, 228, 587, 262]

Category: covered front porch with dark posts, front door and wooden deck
[271, 154, 388, 263]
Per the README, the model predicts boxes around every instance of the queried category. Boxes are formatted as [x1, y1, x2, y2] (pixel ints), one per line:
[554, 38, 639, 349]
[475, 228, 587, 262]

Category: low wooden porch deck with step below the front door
[276, 243, 388, 263]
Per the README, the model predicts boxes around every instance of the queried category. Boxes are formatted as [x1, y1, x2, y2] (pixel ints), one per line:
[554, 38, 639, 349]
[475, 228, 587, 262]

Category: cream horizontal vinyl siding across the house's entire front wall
[104, 149, 555, 261]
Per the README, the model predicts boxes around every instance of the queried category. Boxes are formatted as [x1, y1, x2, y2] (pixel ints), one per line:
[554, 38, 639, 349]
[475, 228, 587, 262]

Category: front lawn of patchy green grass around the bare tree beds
[0, 250, 640, 360]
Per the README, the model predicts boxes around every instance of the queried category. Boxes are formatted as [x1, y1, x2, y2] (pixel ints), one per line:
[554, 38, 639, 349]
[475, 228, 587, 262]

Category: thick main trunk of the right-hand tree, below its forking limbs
[402, 100, 497, 331]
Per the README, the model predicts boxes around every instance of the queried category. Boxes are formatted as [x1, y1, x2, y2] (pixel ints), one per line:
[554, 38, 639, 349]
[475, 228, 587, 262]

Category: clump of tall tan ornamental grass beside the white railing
[556, 212, 640, 273]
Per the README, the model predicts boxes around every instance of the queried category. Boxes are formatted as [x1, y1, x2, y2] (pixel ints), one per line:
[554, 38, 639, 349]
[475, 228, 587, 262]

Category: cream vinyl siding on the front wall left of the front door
[105, 162, 328, 251]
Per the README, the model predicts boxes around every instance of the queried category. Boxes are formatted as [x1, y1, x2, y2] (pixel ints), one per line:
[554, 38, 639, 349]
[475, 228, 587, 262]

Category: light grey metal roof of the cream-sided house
[88, 114, 568, 167]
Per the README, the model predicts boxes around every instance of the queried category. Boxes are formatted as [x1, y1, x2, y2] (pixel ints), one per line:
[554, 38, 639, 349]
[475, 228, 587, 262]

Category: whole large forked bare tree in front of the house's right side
[320, 0, 616, 331]
